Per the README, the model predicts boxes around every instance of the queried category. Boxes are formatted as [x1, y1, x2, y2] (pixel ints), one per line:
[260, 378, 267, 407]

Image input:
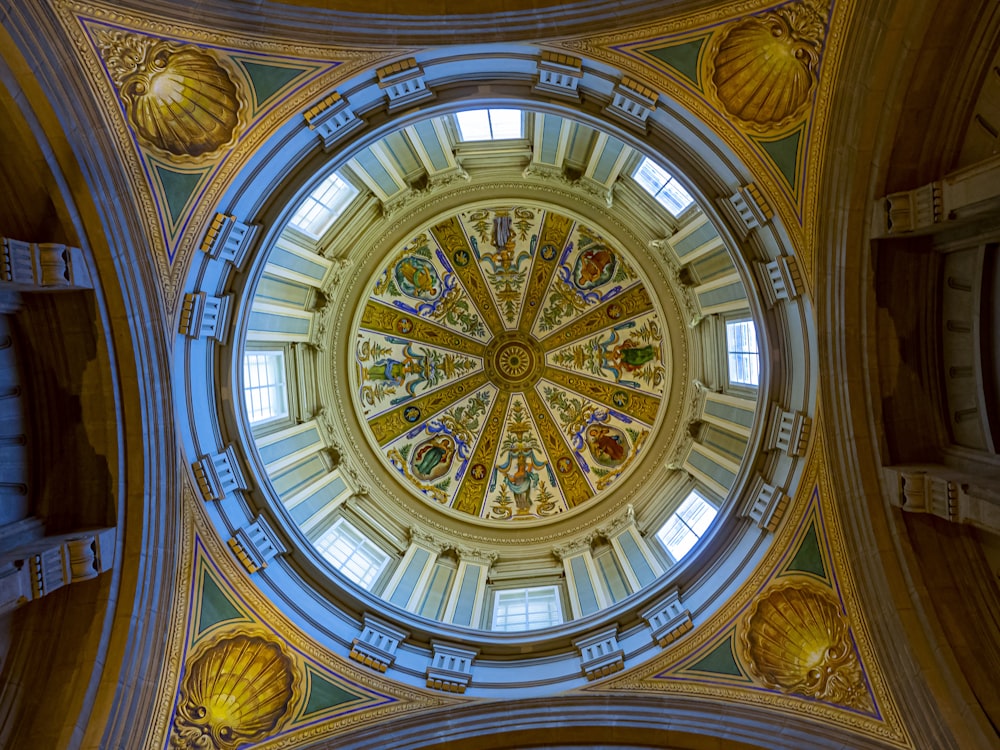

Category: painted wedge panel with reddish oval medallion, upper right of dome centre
[535, 226, 636, 337]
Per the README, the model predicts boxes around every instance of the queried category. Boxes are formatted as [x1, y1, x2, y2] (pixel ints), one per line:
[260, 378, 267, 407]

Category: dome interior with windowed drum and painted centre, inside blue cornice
[240, 103, 766, 645]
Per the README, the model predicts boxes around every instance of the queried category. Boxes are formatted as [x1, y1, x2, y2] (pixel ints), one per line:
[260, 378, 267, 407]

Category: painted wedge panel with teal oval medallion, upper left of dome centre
[373, 233, 488, 339]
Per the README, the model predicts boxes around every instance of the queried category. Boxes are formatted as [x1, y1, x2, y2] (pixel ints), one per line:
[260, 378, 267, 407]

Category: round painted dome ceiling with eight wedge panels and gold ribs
[352, 205, 669, 521]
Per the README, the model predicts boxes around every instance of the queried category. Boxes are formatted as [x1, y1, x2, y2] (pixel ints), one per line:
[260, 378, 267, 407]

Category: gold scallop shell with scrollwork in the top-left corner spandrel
[95, 29, 250, 163]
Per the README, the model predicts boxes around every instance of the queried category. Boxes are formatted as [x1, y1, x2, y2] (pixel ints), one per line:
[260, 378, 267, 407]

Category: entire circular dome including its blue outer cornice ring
[178, 50, 815, 696]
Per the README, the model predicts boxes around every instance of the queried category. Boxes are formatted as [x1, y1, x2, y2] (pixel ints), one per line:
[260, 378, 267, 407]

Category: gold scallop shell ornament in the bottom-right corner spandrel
[740, 582, 873, 712]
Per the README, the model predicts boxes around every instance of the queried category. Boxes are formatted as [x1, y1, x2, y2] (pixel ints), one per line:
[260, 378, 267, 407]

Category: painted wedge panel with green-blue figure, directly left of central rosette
[355, 334, 482, 416]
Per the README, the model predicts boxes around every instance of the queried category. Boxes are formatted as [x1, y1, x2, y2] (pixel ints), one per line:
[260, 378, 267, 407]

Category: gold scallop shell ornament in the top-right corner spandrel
[708, 3, 825, 132]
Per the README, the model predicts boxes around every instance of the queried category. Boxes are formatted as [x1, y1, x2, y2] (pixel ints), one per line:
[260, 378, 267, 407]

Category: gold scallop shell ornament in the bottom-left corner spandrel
[170, 634, 297, 750]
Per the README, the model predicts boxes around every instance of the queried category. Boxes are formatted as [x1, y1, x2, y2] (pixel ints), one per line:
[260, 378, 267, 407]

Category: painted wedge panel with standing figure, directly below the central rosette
[487, 397, 565, 518]
